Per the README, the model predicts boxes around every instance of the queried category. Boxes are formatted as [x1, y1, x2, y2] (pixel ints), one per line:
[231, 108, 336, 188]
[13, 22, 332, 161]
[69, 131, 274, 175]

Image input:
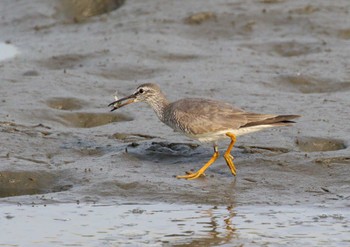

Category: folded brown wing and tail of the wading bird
[164, 98, 298, 135]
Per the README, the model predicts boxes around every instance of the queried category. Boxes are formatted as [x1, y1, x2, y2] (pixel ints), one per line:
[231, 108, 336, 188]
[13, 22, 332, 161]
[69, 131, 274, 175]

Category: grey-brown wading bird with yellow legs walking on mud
[108, 83, 300, 179]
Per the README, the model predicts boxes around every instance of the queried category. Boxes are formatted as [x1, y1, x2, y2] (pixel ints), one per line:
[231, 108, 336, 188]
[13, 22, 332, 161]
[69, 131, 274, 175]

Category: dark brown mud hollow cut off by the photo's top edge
[58, 0, 125, 22]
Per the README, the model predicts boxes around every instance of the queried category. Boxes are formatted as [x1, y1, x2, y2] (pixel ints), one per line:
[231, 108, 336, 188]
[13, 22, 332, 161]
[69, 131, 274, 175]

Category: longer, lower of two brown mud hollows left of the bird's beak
[58, 112, 133, 128]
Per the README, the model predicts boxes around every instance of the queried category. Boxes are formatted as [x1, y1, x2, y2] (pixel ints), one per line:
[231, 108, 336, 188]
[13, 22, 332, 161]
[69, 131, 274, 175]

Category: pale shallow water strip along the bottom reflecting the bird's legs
[0, 203, 350, 246]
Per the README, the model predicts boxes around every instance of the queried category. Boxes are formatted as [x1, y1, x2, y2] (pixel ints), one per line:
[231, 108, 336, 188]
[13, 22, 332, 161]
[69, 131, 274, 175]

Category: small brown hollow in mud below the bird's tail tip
[296, 137, 346, 152]
